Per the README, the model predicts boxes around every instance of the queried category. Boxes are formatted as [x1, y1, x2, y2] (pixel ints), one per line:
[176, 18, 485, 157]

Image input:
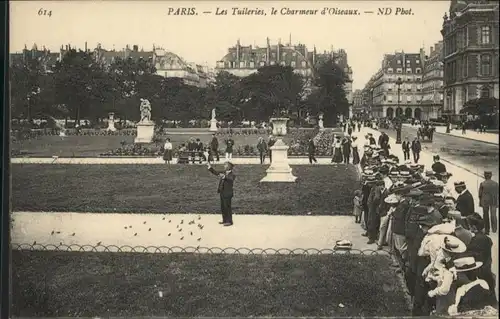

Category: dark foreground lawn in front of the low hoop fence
[11, 251, 409, 317]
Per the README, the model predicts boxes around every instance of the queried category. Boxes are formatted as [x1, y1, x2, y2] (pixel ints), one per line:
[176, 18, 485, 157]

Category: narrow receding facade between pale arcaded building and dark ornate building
[421, 41, 444, 120]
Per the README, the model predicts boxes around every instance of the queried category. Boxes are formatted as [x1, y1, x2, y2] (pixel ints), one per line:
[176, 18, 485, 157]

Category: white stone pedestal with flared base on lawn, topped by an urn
[260, 118, 297, 183]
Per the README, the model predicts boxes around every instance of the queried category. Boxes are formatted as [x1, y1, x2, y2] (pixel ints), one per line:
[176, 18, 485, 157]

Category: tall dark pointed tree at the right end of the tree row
[313, 57, 349, 124]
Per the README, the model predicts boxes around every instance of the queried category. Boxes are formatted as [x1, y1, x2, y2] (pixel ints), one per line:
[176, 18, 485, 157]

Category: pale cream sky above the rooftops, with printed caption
[10, 0, 450, 89]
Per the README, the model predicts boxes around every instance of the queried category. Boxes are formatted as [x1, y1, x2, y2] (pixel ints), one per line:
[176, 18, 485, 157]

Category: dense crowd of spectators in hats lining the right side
[353, 134, 498, 316]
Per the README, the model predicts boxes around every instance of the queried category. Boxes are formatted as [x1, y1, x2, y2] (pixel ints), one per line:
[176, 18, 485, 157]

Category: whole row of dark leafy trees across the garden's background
[10, 49, 349, 124]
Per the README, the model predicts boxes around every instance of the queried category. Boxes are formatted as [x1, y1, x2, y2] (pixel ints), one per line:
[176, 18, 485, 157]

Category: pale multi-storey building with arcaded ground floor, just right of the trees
[364, 49, 428, 119]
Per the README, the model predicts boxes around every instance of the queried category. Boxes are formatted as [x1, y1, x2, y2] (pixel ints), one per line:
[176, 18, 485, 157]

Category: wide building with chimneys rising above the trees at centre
[216, 38, 353, 106]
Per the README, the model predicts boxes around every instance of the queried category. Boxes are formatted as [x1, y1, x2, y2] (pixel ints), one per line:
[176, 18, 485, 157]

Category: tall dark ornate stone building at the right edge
[441, 0, 499, 116]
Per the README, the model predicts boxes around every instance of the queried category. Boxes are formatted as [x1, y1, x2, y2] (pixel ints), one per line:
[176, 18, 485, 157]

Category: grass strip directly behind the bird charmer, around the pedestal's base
[11, 164, 360, 215]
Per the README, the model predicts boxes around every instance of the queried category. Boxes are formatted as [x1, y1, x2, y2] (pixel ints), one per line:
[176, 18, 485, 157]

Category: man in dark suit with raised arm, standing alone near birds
[207, 162, 236, 226]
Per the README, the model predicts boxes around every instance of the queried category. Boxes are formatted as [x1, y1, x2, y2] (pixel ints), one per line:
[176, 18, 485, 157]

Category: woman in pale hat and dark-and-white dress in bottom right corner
[448, 257, 497, 316]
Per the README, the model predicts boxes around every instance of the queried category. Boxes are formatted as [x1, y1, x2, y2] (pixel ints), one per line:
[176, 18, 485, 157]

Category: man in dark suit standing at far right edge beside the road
[479, 171, 498, 235]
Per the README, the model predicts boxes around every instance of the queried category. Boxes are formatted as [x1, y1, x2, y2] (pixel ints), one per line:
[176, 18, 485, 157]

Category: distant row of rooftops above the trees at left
[10, 43, 214, 87]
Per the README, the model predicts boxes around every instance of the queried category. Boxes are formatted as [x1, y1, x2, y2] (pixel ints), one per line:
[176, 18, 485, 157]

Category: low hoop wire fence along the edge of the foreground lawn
[11, 243, 390, 256]
